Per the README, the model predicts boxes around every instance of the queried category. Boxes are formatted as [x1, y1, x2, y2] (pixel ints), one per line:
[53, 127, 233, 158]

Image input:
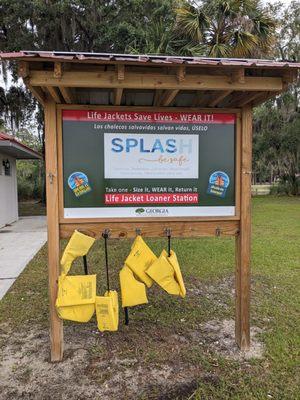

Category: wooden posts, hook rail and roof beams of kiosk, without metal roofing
[20, 51, 286, 361]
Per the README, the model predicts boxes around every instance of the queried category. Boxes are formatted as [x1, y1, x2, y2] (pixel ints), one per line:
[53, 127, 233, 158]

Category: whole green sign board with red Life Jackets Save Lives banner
[62, 109, 236, 219]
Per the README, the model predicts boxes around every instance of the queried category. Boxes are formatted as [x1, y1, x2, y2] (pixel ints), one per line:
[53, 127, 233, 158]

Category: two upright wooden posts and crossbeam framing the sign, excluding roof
[45, 100, 252, 361]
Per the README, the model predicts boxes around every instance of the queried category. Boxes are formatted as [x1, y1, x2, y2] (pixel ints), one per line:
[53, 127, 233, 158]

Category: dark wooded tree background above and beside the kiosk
[0, 0, 300, 200]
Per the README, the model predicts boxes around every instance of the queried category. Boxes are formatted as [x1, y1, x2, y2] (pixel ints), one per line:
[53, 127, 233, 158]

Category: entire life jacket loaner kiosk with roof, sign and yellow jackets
[1, 51, 300, 361]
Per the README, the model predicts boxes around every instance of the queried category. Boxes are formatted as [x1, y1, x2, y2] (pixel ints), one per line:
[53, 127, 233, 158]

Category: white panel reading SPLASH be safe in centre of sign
[104, 133, 199, 179]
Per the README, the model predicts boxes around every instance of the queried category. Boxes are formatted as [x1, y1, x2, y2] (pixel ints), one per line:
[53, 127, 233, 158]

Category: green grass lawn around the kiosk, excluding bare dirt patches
[0, 196, 300, 400]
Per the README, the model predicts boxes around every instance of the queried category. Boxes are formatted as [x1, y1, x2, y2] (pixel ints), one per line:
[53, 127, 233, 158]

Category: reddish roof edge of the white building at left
[0, 132, 42, 160]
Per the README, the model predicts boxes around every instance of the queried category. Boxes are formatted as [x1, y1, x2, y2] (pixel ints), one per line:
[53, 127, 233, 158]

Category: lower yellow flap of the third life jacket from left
[120, 265, 148, 307]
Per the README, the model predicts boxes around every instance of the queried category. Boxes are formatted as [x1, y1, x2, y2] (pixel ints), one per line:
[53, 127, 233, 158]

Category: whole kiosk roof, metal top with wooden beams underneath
[0, 51, 300, 109]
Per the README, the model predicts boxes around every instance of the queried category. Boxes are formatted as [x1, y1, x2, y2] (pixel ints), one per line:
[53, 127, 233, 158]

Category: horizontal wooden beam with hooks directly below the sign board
[60, 220, 239, 238]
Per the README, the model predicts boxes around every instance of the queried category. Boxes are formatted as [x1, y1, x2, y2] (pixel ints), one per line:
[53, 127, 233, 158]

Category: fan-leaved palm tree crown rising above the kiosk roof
[176, 0, 275, 58]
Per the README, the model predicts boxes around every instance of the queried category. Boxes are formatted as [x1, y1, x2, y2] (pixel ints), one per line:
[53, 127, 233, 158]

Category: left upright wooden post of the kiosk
[44, 98, 63, 361]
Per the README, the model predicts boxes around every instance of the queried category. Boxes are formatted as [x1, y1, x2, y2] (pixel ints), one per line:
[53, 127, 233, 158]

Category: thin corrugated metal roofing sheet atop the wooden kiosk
[0, 50, 300, 68]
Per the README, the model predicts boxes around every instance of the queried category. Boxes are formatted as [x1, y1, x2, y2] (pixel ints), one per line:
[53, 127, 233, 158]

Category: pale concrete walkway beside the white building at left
[0, 216, 47, 300]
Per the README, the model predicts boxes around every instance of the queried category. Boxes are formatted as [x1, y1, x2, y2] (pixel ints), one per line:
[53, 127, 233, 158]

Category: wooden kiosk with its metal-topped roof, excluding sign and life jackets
[1, 51, 300, 361]
